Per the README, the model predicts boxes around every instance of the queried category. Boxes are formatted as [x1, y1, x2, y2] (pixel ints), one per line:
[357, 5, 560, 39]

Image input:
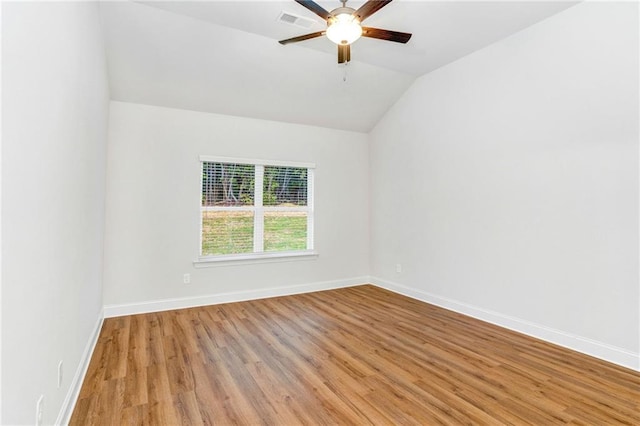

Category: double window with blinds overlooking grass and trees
[200, 156, 314, 261]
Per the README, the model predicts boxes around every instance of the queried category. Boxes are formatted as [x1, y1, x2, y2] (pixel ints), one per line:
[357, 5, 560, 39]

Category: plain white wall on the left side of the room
[0, 2, 108, 424]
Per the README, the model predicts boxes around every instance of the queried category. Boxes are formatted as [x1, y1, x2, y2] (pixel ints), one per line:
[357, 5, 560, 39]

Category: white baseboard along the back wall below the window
[104, 276, 369, 318]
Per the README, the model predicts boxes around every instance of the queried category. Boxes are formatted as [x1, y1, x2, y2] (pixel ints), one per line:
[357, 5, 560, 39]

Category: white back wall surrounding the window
[104, 102, 369, 316]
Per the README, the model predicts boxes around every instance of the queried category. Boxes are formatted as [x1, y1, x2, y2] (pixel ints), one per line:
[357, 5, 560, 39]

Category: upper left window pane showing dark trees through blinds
[202, 163, 255, 206]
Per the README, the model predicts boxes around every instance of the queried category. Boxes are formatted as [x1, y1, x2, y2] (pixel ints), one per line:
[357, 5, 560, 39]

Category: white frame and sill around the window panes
[193, 155, 318, 267]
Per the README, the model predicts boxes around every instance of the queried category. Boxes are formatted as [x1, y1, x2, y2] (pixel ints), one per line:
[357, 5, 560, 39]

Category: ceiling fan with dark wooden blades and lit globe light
[278, 0, 411, 64]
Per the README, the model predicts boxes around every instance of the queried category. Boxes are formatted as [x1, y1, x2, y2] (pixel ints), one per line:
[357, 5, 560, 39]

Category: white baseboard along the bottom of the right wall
[371, 277, 640, 371]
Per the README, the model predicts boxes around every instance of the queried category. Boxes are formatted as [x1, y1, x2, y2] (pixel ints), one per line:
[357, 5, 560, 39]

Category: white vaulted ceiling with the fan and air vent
[100, 0, 575, 132]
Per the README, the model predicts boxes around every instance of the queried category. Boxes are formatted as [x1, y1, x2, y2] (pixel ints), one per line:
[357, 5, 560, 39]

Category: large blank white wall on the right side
[370, 2, 640, 369]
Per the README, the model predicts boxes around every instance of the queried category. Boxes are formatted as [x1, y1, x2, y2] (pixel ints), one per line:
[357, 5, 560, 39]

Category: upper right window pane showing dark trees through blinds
[263, 166, 307, 206]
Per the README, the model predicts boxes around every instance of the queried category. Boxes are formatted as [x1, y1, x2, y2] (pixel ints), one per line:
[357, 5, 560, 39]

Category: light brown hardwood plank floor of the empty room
[71, 285, 640, 425]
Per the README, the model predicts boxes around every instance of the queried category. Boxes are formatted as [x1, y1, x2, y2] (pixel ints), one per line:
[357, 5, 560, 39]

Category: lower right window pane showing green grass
[264, 211, 307, 251]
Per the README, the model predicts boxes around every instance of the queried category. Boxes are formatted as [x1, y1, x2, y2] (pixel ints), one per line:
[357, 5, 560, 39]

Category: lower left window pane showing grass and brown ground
[202, 211, 253, 256]
